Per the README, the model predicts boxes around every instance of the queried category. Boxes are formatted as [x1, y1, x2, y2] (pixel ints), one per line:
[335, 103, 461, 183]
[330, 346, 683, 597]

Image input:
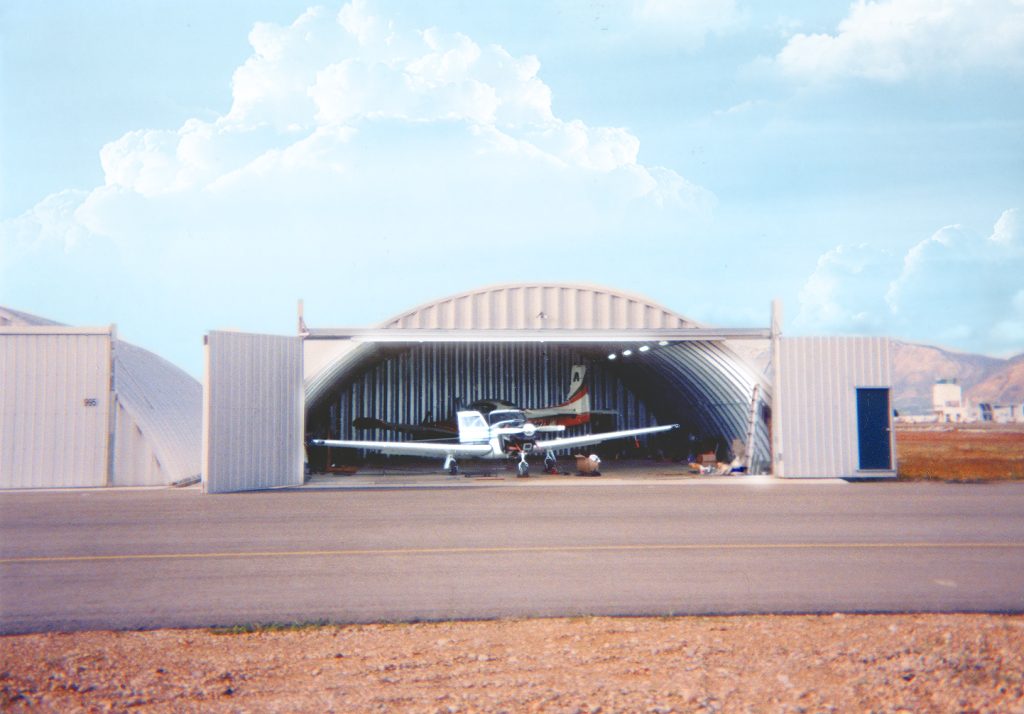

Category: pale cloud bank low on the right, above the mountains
[794, 208, 1024, 354]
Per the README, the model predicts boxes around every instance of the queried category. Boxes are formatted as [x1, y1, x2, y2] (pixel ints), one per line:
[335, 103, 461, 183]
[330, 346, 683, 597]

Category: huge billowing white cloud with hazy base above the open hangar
[0, 1, 714, 366]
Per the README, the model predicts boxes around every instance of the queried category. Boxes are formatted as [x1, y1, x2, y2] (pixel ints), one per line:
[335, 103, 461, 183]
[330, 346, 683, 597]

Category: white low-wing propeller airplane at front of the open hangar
[308, 409, 679, 477]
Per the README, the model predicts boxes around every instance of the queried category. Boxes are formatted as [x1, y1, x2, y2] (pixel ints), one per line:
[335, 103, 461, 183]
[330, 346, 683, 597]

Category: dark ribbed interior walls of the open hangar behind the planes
[306, 340, 769, 471]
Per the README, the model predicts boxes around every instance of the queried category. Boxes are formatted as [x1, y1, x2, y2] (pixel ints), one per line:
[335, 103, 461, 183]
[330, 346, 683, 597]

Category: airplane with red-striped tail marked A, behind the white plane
[352, 365, 615, 438]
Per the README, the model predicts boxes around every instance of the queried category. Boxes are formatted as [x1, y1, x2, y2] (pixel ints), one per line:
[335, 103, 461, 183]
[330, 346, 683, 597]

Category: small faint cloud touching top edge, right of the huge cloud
[632, 0, 743, 49]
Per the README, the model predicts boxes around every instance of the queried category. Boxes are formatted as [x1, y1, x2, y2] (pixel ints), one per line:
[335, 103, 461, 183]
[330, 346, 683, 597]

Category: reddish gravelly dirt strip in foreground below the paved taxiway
[0, 615, 1024, 713]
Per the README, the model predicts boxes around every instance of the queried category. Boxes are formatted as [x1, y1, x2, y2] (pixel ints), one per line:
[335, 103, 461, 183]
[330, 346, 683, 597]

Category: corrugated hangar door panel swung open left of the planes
[203, 332, 304, 494]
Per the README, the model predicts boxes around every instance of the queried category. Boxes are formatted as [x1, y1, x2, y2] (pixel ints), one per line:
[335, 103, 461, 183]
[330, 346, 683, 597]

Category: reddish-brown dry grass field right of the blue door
[896, 424, 1024, 481]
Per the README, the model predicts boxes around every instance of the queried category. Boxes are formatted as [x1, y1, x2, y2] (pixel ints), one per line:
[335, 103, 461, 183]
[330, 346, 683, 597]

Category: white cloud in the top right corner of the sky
[774, 0, 1024, 83]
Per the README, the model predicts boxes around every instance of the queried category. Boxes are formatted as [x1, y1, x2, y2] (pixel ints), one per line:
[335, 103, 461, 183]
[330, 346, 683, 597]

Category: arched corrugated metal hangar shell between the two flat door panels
[304, 285, 771, 470]
